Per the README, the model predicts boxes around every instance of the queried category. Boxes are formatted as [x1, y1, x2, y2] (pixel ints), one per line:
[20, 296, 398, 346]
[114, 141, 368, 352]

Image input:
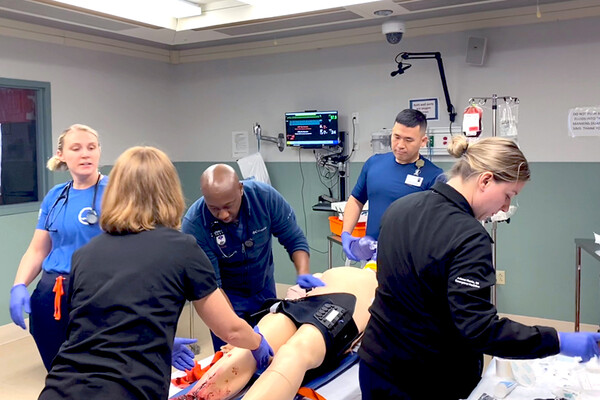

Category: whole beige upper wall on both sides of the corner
[0, 10, 600, 164]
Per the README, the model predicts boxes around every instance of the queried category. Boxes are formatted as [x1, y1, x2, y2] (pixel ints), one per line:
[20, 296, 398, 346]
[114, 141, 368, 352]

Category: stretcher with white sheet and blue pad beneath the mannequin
[169, 351, 361, 400]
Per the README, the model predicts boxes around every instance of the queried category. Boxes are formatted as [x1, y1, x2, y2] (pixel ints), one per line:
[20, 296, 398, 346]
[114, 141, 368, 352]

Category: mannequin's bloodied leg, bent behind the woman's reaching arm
[182, 314, 296, 400]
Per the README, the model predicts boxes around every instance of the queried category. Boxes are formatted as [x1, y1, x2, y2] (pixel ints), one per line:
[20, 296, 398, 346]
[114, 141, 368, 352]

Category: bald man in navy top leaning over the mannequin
[182, 164, 323, 351]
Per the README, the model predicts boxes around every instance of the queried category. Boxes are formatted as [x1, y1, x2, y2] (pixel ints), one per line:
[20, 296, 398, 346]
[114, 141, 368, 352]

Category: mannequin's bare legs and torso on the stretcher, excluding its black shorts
[176, 267, 377, 400]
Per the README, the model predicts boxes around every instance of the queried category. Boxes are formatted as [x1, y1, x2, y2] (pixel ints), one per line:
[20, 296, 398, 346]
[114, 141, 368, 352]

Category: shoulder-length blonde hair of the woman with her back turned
[100, 146, 185, 233]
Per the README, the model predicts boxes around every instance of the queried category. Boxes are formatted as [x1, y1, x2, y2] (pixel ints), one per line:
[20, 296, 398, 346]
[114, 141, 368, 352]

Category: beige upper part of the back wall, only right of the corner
[168, 18, 600, 162]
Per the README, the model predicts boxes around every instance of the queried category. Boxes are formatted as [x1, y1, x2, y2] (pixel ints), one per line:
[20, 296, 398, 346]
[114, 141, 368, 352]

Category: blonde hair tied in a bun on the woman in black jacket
[448, 135, 531, 182]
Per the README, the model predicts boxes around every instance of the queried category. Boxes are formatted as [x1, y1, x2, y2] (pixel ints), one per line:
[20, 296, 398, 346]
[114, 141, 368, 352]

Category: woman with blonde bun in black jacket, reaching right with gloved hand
[358, 135, 600, 400]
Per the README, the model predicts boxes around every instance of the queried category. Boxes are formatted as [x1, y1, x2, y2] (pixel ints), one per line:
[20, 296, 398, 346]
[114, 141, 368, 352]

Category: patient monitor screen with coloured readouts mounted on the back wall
[285, 111, 340, 148]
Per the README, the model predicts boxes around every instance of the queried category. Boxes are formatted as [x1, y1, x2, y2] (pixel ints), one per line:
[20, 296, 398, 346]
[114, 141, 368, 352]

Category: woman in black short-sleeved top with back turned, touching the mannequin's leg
[40, 147, 273, 400]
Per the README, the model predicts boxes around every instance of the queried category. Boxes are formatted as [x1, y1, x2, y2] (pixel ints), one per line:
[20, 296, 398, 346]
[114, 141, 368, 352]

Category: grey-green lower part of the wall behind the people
[0, 162, 600, 325]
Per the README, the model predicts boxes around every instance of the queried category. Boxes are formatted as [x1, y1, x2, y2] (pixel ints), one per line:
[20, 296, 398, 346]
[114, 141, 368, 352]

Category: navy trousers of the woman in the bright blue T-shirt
[29, 271, 69, 371]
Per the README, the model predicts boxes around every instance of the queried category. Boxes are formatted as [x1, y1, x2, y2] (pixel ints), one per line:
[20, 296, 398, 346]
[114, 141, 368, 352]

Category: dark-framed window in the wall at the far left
[0, 78, 52, 215]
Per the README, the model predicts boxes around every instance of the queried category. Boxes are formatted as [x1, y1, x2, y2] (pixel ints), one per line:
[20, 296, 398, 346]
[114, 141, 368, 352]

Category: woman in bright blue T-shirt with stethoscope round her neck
[10, 124, 108, 370]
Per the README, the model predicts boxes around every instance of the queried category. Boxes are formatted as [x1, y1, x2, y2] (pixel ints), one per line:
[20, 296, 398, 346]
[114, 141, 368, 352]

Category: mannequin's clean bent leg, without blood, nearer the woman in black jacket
[244, 324, 326, 400]
